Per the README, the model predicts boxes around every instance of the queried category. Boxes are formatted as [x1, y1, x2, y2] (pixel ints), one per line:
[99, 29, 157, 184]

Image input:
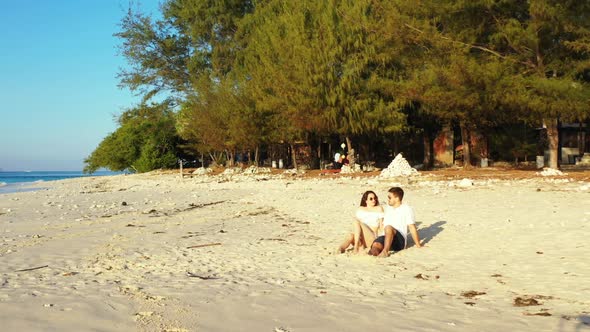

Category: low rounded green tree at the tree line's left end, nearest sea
[84, 103, 179, 173]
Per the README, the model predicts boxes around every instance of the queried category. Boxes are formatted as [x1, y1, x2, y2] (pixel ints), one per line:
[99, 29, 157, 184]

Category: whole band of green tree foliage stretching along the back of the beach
[104, 0, 590, 170]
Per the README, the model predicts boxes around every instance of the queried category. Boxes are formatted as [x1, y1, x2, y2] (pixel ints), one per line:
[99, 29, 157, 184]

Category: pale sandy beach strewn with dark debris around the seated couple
[0, 172, 590, 332]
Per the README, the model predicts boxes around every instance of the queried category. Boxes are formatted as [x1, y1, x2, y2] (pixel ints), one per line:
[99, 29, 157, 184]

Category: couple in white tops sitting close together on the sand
[339, 187, 422, 257]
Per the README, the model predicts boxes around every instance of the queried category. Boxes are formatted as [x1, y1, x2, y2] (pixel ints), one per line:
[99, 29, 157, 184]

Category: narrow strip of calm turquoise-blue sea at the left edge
[0, 171, 122, 194]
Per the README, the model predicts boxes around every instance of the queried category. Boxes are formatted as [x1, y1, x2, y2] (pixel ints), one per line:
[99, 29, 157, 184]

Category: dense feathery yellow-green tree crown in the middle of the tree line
[240, 0, 404, 140]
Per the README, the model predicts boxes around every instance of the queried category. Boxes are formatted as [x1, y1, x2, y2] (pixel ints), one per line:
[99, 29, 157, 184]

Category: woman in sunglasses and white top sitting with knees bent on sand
[339, 190, 383, 253]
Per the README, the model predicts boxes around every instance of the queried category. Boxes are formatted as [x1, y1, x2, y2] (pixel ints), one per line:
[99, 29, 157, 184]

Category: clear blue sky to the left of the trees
[0, 0, 160, 171]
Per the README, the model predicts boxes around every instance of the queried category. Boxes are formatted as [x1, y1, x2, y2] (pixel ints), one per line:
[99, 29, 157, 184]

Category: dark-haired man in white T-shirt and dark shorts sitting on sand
[369, 187, 422, 257]
